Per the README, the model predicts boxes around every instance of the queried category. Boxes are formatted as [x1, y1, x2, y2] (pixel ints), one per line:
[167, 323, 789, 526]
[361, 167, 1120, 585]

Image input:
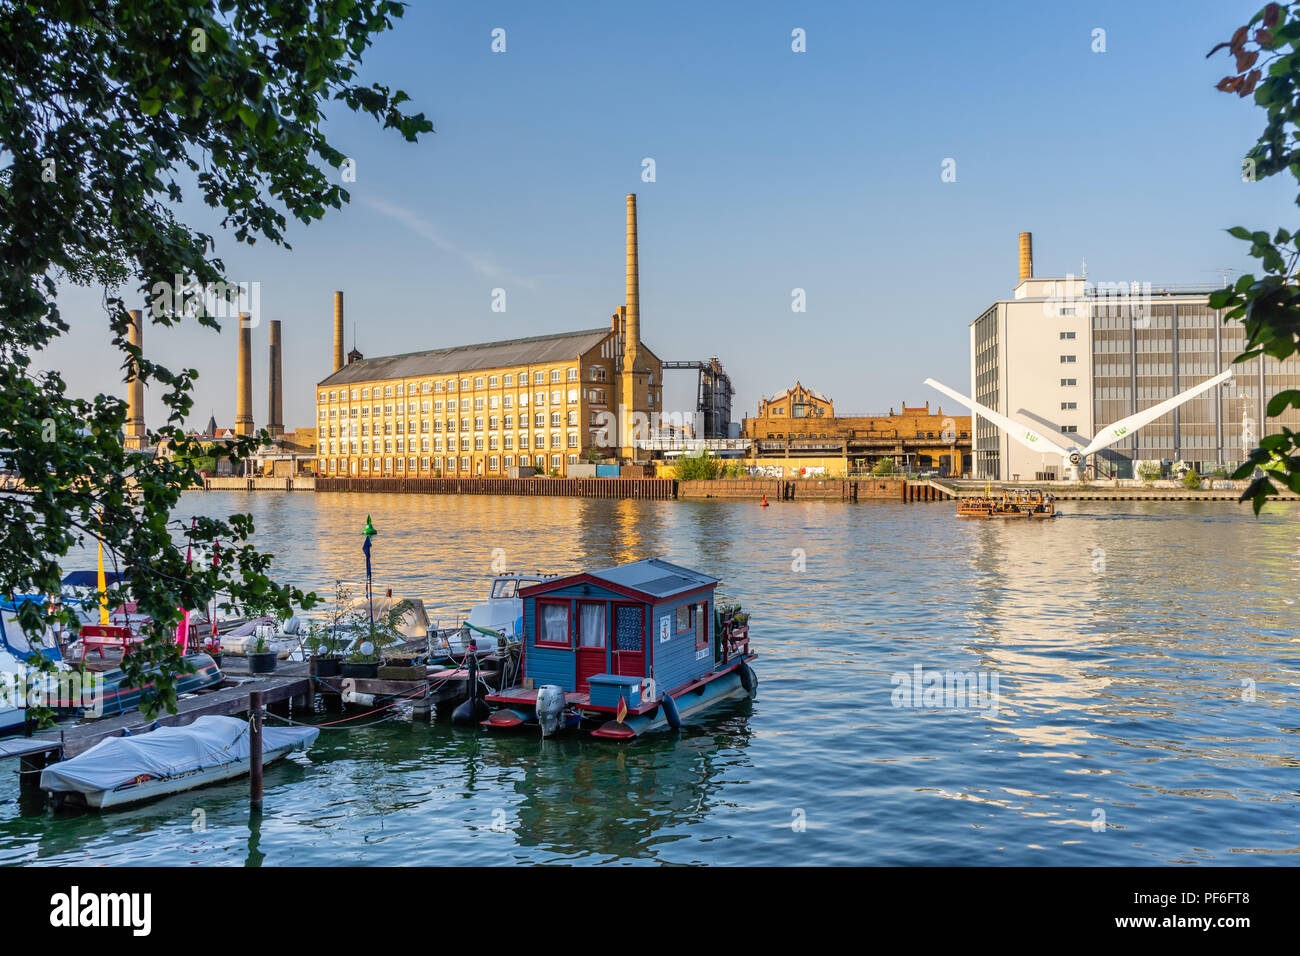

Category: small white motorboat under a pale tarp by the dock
[40, 714, 320, 810]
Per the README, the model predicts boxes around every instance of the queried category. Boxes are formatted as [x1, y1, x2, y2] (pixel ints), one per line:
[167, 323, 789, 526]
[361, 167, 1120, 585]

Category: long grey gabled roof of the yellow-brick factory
[319, 328, 610, 386]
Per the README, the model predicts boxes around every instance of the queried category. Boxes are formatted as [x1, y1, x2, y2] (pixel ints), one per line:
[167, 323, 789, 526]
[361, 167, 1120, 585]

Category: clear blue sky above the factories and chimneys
[38, 0, 1296, 428]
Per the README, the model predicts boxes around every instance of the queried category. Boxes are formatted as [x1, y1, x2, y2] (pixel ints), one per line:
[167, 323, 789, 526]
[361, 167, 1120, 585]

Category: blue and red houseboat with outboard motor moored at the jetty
[482, 558, 758, 740]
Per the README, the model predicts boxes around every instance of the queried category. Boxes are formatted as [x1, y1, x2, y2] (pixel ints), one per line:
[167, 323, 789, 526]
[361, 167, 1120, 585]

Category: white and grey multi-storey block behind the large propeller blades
[970, 233, 1300, 481]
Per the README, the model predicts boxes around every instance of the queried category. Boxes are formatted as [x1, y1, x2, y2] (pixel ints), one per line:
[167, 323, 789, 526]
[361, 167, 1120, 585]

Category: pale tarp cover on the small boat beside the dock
[40, 715, 320, 793]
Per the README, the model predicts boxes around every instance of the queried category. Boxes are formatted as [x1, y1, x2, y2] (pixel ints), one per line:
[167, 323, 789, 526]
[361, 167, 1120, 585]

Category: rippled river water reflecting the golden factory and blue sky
[0, 493, 1300, 865]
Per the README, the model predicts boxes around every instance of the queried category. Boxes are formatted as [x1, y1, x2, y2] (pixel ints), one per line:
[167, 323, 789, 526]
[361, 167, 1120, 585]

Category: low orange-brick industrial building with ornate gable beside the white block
[741, 382, 971, 476]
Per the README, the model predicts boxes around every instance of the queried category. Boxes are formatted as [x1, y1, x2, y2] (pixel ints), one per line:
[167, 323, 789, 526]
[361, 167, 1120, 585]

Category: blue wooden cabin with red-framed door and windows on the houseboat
[519, 558, 718, 709]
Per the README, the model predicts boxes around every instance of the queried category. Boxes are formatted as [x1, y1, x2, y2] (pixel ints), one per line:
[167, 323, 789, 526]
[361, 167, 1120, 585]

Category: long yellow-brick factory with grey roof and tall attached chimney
[316, 194, 663, 477]
